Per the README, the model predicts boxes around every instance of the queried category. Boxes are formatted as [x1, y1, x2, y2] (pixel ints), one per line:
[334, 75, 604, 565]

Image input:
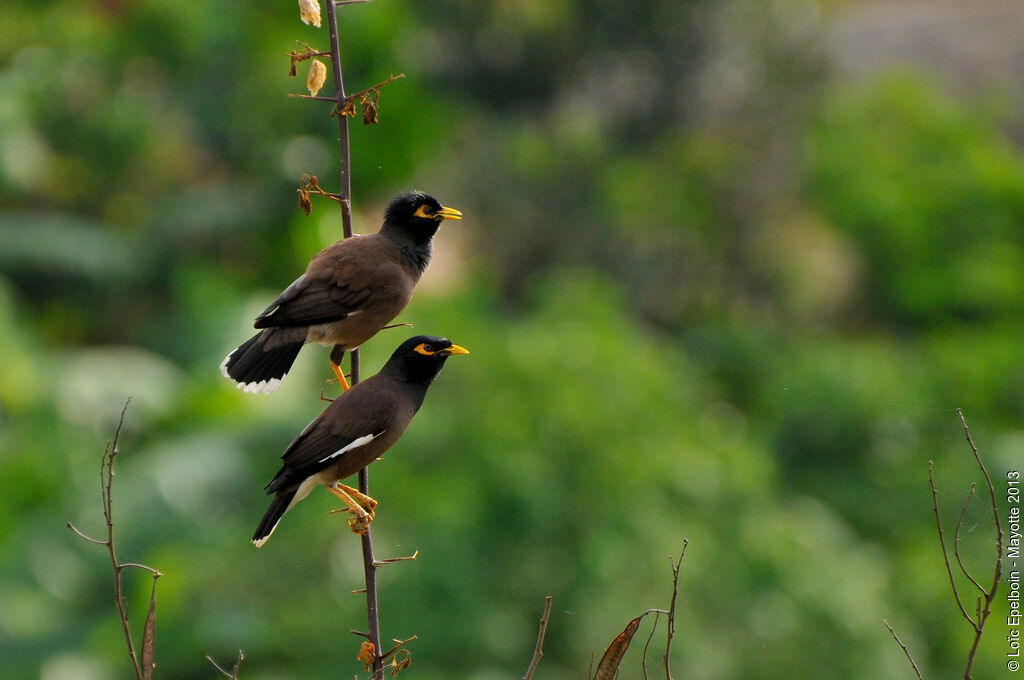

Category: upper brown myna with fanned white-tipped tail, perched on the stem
[220, 190, 462, 393]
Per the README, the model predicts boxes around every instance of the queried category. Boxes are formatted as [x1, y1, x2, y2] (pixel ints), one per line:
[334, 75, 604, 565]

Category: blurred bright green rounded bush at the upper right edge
[809, 70, 1024, 326]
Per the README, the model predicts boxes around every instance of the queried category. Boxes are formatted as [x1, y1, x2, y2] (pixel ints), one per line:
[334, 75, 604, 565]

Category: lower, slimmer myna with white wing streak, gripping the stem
[252, 335, 469, 548]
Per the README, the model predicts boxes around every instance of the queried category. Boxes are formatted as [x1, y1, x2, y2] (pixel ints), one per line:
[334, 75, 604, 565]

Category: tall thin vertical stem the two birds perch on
[325, 0, 384, 678]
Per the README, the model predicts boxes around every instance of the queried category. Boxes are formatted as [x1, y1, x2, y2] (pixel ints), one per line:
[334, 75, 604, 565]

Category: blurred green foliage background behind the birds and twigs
[0, 0, 1024, 680]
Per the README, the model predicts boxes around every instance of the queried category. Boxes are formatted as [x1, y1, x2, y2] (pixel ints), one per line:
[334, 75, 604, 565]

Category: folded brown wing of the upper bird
[254, 235, 401, 328]
